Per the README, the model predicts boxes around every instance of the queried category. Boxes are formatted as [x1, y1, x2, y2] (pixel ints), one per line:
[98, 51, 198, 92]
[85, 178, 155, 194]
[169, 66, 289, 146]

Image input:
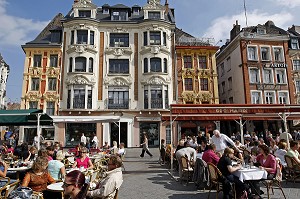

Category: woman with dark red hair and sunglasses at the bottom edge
[62, 170, 89, 199]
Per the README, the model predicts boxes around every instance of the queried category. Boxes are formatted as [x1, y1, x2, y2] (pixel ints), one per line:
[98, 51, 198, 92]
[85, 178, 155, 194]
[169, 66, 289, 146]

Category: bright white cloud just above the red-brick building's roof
[204, 10, 293, 42]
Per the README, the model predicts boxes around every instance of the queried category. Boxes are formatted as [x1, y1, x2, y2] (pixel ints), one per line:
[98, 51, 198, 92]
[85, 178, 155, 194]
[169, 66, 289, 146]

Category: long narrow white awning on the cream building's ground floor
[52, 115, 120, 123]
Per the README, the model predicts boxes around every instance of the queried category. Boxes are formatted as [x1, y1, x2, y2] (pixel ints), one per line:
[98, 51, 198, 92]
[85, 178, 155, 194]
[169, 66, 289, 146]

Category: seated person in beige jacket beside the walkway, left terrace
[87, 155, 123, 198]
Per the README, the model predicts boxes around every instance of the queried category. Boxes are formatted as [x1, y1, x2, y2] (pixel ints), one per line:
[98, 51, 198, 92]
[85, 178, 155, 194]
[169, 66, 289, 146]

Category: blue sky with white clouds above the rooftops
[0, 0, 300, 102]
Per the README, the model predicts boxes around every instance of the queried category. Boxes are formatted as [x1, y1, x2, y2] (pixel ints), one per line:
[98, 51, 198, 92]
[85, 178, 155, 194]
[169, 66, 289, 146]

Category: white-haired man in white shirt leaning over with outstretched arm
[211, 129, 235, 154]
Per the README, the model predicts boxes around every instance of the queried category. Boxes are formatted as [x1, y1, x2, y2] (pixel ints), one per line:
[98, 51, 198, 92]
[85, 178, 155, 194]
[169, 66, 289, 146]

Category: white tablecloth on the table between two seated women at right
[233, 167, 268, 182]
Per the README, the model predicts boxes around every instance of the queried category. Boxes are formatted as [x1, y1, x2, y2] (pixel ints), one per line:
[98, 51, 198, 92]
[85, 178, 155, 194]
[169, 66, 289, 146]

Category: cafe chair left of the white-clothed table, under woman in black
[207, 162, 236, 199]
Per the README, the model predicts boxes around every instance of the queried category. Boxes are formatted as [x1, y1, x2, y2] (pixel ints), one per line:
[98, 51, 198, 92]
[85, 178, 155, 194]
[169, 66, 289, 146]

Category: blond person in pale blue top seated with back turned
[48, 151, 66, 180]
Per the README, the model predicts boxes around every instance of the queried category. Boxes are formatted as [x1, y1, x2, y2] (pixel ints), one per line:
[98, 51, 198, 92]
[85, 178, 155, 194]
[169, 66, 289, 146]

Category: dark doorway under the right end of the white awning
[110, 122, 128, 147]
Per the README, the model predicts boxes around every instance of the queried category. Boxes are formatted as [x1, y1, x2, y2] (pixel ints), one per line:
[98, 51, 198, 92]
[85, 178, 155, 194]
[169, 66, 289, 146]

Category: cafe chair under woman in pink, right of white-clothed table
[262, 159, 286, 199]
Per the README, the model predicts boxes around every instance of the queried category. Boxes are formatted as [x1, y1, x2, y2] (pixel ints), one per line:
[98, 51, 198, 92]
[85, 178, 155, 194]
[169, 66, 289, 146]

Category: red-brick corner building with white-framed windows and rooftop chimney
[216, 21, 295, 133]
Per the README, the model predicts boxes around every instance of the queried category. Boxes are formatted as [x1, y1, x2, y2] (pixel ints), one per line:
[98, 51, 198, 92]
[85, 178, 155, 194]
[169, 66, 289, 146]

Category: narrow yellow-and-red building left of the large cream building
[19, 14, 64, 143]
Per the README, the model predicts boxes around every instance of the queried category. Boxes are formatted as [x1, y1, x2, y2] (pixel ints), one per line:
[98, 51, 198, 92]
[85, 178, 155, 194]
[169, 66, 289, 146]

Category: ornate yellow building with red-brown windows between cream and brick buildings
[175, 29, 219, 138]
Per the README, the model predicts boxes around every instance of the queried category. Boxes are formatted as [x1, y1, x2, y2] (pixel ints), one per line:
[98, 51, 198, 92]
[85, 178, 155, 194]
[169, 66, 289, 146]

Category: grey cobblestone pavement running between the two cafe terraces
[119, 148, 300, 199]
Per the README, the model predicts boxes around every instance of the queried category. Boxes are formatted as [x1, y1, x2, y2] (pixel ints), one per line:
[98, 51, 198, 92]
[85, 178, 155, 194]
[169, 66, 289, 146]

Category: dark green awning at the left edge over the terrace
[0, 109, 53, 126]
